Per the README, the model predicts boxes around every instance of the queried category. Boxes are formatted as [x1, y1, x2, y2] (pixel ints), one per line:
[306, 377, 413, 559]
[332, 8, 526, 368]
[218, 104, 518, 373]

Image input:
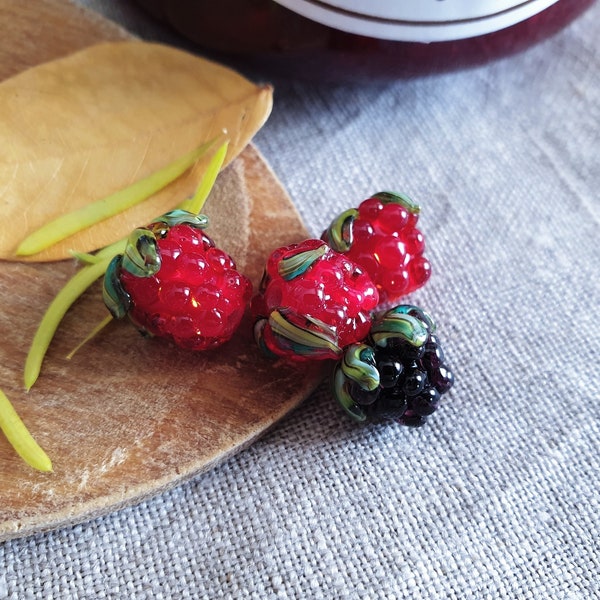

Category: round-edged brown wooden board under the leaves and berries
[0, 0, 326, 541]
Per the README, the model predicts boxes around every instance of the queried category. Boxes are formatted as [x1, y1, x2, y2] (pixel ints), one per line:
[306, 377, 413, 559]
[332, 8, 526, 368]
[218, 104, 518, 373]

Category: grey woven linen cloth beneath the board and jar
[0, 0, 600, 600]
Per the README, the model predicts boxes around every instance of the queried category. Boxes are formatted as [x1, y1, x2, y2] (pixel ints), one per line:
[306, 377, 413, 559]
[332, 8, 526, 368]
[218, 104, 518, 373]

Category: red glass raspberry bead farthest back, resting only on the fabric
[323, 192, 431, 307]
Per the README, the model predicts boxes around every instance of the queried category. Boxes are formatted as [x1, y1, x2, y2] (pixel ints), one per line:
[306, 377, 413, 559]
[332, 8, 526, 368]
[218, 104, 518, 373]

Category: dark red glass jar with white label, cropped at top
[138, 0, 593, 81]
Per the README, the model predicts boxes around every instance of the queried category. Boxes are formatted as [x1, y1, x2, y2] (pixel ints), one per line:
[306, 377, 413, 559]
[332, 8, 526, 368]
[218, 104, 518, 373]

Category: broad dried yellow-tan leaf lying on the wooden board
[0, 41, 272, 261]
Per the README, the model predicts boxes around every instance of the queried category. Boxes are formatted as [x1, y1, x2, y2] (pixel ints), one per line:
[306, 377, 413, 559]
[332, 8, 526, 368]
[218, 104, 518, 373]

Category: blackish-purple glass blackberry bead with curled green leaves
[332, 304, 454, 427]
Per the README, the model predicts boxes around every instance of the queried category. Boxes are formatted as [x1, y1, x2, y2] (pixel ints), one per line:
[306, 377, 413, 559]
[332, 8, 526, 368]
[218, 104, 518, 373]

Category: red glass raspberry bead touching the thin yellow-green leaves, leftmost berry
[105, 211, 252, 350]
